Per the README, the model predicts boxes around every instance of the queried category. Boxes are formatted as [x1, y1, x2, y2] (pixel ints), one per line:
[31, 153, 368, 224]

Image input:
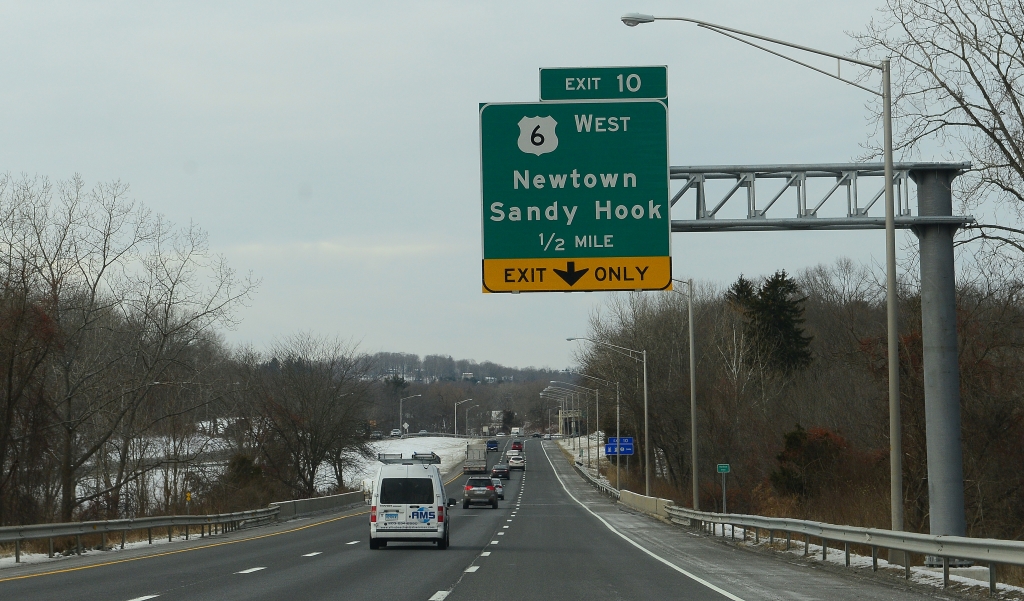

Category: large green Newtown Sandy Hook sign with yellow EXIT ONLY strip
[479, 100, 672, 292]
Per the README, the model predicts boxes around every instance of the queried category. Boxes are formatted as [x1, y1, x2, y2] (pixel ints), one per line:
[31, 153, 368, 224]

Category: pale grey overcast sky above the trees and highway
[0, 0, 942, 368]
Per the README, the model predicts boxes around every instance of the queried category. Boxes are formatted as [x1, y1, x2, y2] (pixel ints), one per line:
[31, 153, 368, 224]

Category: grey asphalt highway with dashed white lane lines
[0, 439, 950, 601]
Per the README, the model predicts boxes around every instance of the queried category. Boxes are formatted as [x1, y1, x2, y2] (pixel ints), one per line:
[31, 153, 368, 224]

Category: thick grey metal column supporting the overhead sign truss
[910, 170, 967, 536]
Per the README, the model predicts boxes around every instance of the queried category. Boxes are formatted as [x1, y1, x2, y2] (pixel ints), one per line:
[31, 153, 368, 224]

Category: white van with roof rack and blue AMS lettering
[370, 453, 456, 549]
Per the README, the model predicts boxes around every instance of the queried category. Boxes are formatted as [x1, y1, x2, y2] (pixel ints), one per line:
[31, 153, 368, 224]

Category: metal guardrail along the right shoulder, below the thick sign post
[667, 506, 1024, 594]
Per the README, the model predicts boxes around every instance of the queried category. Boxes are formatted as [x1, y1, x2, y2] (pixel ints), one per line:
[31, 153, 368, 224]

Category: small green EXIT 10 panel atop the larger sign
[541, 66, 669, 101]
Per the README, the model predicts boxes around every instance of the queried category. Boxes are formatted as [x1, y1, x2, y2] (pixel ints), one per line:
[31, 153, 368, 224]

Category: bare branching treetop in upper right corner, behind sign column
[854, 0, 1024, 251]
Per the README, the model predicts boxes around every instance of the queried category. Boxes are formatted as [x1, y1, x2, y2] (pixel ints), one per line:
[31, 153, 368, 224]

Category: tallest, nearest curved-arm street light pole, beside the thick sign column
[622, 12, 903, 530]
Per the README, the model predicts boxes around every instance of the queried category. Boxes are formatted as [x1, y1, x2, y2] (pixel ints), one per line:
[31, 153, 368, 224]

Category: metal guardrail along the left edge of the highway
[0, 507, 281, 563]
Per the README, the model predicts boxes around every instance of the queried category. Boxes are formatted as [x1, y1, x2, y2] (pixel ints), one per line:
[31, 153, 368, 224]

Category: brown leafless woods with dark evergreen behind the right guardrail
[579, 260, 1024, 539]
